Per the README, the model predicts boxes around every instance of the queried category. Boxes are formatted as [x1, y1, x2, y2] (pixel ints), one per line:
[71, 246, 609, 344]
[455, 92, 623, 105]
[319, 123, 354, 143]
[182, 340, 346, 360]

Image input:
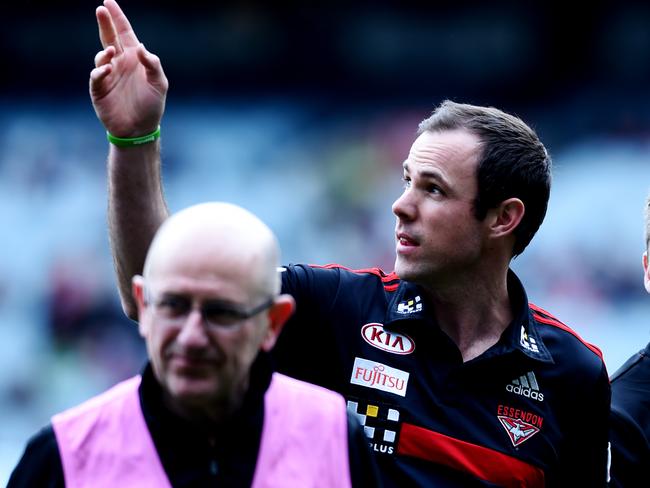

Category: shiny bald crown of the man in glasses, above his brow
[144, 202, 280, 296]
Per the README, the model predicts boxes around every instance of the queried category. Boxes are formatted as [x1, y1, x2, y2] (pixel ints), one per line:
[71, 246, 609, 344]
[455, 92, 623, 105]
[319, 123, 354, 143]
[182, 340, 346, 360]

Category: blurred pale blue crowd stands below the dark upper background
[0, 98, 650, 482]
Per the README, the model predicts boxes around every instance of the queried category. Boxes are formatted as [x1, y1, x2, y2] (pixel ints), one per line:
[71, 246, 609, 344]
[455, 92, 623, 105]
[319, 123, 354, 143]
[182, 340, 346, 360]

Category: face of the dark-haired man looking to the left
[393, 130, 484, 284]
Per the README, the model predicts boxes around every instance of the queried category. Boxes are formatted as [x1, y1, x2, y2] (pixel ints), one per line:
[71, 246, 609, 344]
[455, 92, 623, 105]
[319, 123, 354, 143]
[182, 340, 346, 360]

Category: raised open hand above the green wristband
[90, 0, 169, 137]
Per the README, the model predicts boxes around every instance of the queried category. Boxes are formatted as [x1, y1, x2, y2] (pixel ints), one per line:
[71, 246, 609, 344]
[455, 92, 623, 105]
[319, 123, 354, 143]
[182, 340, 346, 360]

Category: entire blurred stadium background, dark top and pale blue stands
[0, 0, 650, 483]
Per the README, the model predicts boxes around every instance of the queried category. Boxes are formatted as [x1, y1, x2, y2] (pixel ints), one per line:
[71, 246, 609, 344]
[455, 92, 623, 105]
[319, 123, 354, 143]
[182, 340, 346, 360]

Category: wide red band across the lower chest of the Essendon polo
[397, 423, 544, 488]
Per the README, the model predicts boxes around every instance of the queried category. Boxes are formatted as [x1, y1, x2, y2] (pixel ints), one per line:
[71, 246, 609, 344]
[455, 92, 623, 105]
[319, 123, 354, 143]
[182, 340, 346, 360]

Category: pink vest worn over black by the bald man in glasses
[52, 373, 351, 488]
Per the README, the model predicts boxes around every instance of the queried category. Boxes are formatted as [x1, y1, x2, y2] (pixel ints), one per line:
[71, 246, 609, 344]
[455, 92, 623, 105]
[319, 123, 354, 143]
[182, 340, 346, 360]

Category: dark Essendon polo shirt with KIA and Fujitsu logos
[273, 265, 610, 488]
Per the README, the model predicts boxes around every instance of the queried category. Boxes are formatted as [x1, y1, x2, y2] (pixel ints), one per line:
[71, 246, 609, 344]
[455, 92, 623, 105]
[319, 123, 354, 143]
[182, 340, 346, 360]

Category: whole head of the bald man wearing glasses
[133, 202, 295, 422]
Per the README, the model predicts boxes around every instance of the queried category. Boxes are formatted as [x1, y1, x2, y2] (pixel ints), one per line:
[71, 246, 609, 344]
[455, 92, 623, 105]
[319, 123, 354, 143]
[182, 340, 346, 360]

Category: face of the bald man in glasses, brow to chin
[140, 261, 269, 407]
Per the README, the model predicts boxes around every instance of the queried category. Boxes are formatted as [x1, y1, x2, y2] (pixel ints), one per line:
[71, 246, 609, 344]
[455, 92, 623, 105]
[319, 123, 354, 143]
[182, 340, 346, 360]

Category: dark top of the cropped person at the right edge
[610, 344, 650, 488]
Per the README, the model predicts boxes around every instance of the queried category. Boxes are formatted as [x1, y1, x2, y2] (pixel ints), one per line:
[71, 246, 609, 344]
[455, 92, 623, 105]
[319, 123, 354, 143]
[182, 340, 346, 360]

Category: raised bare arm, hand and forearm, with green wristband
[90, 0, 168, 319]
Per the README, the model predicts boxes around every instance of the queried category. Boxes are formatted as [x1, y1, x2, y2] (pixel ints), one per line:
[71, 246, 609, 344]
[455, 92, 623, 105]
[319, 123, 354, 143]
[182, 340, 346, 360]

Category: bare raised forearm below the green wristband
[108, 141, 168, 320]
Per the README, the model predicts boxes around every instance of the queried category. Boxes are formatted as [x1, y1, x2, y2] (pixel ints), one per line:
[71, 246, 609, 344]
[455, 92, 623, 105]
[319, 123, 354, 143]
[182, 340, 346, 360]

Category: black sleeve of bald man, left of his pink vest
[7, 425, 65, 488]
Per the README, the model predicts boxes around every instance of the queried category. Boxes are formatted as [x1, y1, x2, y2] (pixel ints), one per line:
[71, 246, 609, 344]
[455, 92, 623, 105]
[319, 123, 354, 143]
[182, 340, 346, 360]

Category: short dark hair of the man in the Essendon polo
[418, 100, 551, 256]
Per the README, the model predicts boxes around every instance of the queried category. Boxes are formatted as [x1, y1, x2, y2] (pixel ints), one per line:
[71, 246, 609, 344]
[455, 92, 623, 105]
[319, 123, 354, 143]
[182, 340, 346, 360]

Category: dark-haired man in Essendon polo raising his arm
[90, 0, 610, 487]
